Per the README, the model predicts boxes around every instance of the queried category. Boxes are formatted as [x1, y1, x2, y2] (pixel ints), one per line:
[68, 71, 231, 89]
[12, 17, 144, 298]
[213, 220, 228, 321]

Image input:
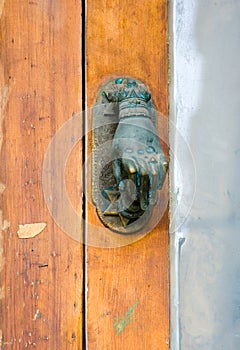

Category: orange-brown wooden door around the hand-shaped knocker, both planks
[0, 0, 169, 350]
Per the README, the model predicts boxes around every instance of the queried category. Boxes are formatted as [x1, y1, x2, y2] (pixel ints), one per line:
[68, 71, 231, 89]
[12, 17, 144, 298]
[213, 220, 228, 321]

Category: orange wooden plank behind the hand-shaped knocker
[87, 0, 169, 350]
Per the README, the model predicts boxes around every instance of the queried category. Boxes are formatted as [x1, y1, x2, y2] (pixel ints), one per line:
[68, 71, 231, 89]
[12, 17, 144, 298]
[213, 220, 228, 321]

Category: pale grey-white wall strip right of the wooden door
[170, 0, 240, 350]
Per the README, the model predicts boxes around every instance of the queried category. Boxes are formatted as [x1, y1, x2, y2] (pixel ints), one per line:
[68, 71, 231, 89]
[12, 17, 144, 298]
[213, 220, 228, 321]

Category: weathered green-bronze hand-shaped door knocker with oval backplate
[92, 78, 168, 234]
